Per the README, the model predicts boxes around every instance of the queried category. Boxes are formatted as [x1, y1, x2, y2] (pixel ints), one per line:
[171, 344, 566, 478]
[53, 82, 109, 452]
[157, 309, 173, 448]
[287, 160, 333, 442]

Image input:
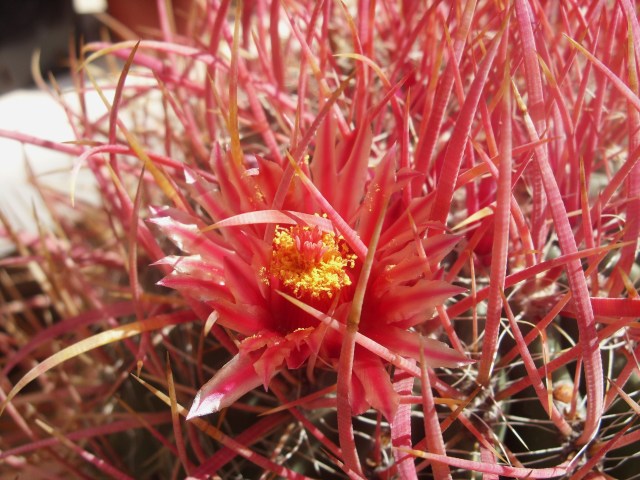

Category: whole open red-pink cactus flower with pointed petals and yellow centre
[153, 129, 469, 419]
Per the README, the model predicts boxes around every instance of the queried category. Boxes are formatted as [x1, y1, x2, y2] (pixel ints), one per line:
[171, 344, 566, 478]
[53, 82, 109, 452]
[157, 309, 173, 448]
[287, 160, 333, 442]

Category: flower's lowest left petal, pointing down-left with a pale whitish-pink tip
[187, 354, 262, 420]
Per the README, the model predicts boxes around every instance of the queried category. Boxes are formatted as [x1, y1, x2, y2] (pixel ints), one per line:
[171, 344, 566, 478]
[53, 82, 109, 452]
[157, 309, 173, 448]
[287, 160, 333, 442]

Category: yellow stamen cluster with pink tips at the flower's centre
[269, 226, 356, 299]
